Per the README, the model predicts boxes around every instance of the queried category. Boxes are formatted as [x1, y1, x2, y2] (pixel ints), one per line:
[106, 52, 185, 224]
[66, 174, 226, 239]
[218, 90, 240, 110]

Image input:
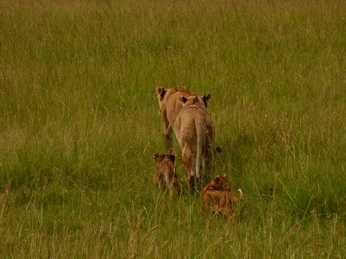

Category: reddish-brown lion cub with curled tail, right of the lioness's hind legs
[202, 175, 243, 217]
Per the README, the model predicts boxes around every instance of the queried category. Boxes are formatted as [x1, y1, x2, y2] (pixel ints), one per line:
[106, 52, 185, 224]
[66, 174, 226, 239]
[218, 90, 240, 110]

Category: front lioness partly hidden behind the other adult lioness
[156, 86, 211, 154]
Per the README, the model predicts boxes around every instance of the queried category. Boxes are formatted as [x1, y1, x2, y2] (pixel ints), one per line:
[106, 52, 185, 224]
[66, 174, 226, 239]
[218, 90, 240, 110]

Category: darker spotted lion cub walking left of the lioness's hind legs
[154, 154, 179, 195]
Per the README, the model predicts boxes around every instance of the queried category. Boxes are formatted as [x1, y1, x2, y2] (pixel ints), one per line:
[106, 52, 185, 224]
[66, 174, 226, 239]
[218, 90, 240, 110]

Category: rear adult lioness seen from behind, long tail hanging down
[173, 95, 214, 188]
